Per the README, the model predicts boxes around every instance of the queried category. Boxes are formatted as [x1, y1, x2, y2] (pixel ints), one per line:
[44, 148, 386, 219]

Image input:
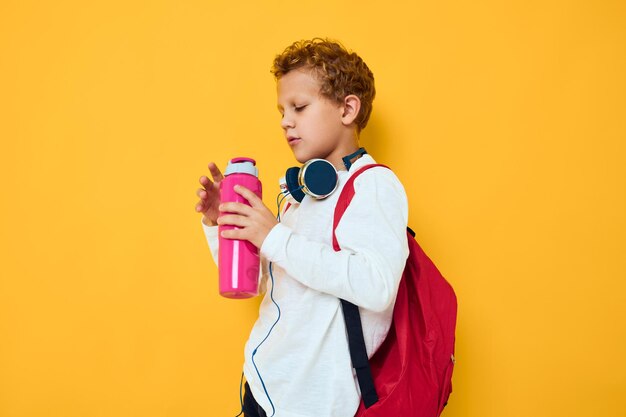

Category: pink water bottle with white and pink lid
[218, 158, 262, 298]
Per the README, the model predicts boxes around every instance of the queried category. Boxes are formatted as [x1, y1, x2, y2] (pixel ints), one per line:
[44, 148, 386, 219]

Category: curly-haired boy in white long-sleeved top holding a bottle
[196, 38, 408, 417]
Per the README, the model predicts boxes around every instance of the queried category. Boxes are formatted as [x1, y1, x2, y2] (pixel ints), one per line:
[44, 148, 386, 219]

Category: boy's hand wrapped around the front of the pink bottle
[217, 185, 278, 248]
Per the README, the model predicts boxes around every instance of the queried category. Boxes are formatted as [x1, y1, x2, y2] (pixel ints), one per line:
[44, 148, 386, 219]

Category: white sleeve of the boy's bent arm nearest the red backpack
[261, 168, 409, 311]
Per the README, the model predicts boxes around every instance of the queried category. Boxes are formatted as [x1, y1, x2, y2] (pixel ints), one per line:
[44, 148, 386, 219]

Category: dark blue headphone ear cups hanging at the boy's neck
[285, 159, 338, 203]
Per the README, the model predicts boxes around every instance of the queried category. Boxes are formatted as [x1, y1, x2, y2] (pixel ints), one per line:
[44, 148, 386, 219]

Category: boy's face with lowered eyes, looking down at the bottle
[277, 69, 346, 166]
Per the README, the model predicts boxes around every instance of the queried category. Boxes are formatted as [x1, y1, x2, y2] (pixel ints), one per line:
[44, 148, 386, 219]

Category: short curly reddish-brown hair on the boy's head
[271, 38, 376, 132]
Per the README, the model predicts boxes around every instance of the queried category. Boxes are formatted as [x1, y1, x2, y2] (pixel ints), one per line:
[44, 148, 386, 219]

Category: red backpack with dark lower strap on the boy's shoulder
[333, 165, 457, 417]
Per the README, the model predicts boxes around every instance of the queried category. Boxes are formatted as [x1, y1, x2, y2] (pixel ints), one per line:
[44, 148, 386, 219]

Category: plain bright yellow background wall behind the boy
[0, 0, 626, 417]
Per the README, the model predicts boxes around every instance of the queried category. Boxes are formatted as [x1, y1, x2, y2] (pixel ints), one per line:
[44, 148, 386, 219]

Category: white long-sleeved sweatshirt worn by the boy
[203, 155, 409, 417]
